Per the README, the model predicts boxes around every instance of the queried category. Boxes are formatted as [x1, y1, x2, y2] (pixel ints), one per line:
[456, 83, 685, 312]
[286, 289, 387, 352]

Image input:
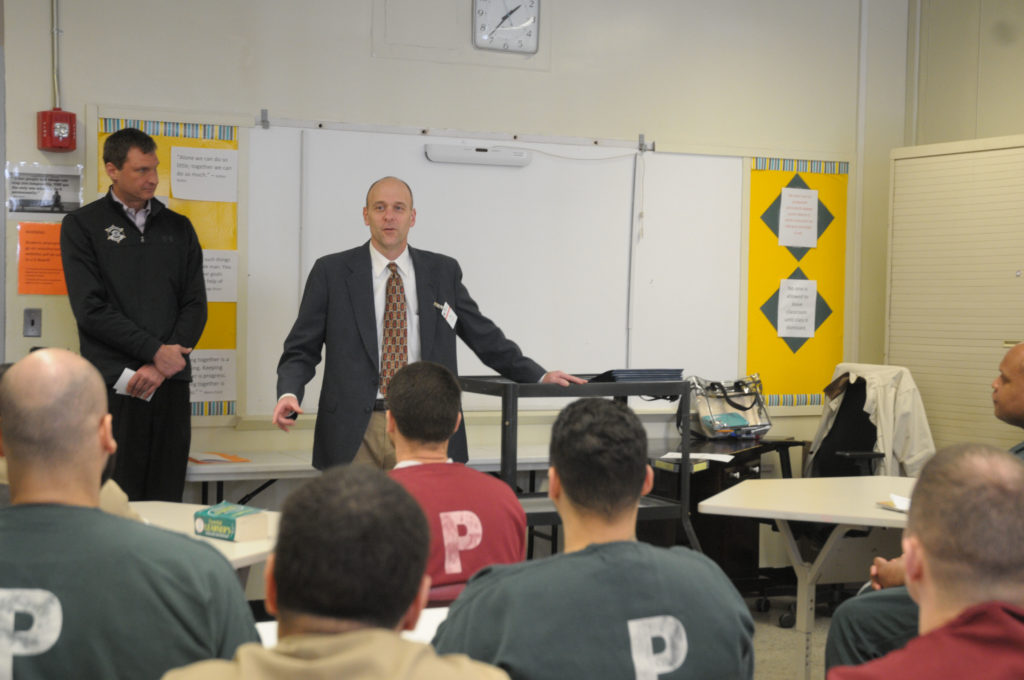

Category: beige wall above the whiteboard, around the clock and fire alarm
[3, 0, 911, 449]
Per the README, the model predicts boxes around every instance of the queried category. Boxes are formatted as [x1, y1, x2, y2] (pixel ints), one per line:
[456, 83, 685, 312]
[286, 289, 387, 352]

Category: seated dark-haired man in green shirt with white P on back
[434, 398, 754, 680]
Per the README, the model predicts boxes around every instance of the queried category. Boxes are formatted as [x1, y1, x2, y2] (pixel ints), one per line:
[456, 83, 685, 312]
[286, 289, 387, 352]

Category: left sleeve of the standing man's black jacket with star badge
[60, 213, 164, 362]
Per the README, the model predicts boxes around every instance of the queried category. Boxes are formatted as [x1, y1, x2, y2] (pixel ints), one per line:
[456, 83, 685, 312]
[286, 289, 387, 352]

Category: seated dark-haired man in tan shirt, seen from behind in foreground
[165, 465, 508, 680]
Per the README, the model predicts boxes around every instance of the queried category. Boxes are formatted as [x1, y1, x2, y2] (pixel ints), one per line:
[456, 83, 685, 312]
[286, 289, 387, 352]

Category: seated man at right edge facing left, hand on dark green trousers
[825, 343, 1024, 669]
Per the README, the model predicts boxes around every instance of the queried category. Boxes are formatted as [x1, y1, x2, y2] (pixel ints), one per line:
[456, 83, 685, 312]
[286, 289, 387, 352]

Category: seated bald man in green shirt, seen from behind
[0, 349, 258, 680]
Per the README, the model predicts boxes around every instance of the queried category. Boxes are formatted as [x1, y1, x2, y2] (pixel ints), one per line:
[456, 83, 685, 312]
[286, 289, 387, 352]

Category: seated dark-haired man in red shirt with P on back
[387, 362, 526, 602]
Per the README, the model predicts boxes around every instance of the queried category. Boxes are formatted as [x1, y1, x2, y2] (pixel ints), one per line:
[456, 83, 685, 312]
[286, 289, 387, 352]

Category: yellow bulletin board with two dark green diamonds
[746, 158, 849, 406]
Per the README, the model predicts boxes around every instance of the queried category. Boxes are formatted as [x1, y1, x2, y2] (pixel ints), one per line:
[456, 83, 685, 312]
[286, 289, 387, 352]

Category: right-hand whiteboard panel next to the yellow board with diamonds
[629, 153, 743, 380]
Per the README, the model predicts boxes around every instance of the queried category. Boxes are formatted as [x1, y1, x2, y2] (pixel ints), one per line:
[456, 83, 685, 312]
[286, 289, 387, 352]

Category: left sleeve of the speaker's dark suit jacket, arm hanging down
[278, 261, 330, 402]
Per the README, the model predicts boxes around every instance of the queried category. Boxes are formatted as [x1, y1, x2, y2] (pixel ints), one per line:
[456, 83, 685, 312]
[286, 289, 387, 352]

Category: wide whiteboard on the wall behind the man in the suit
[243, 127, 742, 415]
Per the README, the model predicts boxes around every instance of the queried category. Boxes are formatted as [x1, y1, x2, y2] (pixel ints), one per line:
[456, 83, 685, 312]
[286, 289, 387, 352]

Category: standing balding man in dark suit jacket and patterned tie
[273, 177, 584, 469]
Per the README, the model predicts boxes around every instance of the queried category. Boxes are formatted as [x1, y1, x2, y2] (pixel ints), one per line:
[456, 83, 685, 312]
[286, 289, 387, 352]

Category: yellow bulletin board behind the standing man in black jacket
[96, 117, 239, 416]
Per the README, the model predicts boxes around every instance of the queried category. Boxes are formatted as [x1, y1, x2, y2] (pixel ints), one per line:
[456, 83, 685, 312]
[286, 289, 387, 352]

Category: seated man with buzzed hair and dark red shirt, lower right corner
[828, 444, 1024, 680]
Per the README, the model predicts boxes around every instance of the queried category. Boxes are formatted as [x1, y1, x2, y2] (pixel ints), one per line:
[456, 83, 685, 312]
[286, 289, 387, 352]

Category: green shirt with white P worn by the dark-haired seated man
[433, 542, 754, 680]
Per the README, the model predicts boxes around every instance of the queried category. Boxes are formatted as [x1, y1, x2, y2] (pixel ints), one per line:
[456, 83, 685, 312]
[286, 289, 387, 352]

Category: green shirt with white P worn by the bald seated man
[0, 505, 259, 680]
